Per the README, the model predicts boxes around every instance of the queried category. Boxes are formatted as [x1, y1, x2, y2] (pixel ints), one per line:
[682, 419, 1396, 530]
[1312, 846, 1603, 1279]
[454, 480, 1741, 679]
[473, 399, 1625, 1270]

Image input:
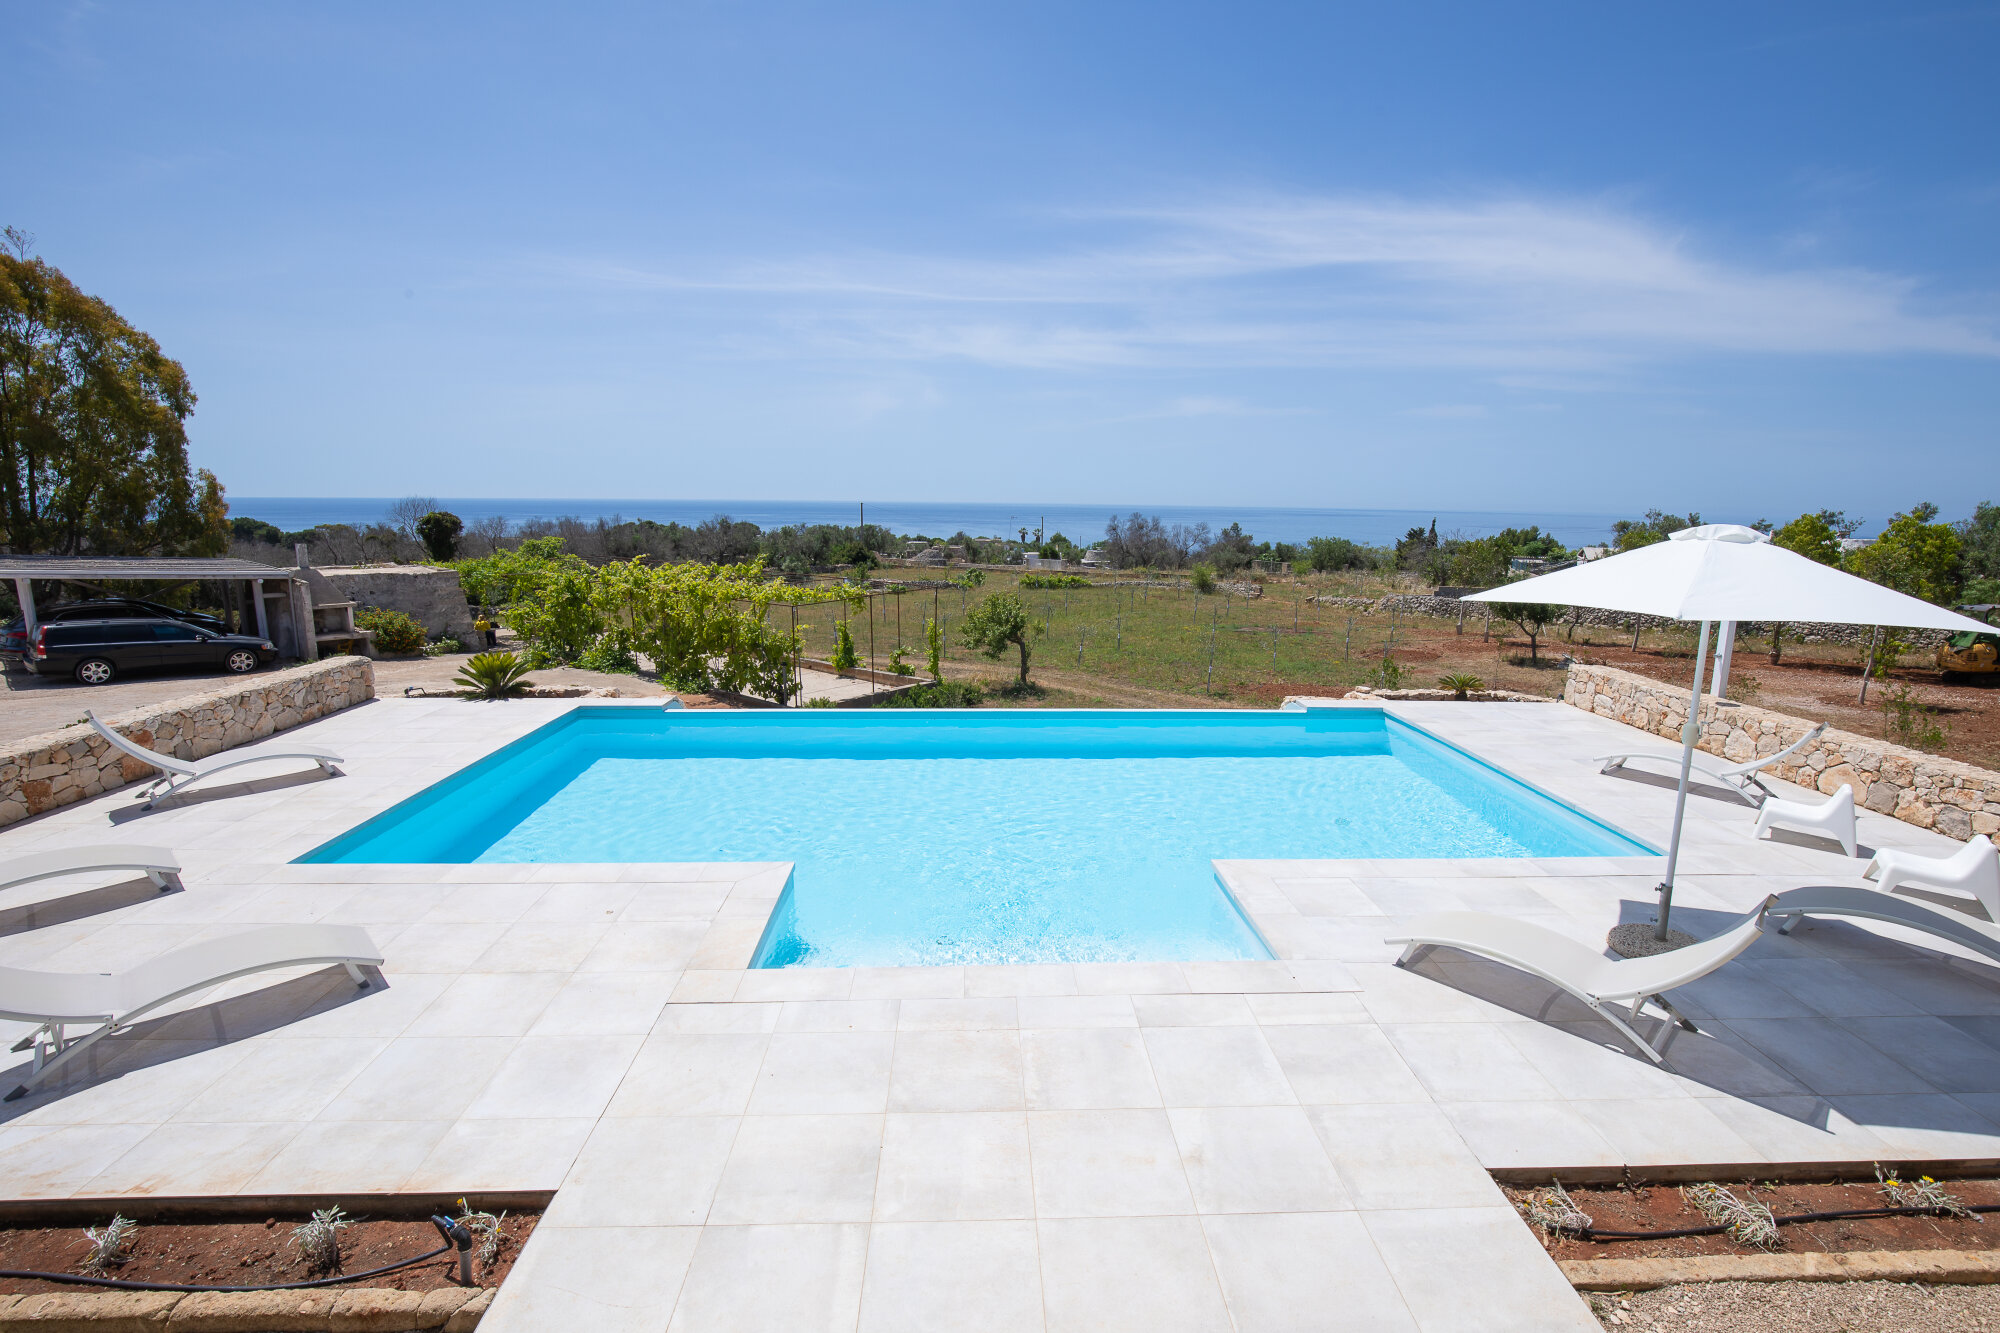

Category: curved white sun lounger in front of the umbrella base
[1384, 897, 1778, 1065]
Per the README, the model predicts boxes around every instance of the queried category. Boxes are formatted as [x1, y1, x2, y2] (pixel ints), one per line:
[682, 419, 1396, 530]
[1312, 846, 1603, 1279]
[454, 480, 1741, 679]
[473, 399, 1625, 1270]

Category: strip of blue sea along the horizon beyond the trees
[230, 496, 1656, 546]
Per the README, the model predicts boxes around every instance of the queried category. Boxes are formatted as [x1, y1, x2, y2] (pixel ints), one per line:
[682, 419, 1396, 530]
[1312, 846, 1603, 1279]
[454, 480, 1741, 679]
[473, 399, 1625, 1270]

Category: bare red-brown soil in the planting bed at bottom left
[0, 1211, 540, 1295]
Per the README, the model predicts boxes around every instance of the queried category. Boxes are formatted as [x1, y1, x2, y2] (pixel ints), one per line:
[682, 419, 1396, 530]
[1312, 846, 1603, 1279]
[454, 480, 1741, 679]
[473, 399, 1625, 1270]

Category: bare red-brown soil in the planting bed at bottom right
[1506, 1179, 2000, 1259]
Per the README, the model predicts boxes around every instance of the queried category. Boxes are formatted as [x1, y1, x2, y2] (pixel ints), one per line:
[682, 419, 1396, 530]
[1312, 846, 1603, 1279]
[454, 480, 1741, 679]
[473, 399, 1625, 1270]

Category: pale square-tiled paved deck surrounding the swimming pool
[0, 699, 2000, 1333]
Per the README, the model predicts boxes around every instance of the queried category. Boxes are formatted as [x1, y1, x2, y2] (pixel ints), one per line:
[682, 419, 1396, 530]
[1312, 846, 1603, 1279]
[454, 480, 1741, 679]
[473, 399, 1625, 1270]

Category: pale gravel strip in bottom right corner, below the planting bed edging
[1590, 1283, 2000, 1333]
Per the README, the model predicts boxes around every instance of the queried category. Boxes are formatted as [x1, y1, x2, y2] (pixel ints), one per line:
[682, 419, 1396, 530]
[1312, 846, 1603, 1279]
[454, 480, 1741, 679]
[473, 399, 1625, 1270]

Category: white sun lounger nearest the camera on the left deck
[0, 925, 382, 1101]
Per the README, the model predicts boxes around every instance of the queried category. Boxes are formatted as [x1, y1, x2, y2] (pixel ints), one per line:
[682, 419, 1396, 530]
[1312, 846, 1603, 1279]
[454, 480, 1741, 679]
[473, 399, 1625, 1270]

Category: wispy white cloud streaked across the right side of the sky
[540, 196, 2000, 376]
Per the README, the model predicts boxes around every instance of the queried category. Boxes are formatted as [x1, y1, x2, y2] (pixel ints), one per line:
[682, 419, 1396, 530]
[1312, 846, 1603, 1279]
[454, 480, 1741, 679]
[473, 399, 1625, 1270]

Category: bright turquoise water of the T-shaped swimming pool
[304, 707, 1650, 967]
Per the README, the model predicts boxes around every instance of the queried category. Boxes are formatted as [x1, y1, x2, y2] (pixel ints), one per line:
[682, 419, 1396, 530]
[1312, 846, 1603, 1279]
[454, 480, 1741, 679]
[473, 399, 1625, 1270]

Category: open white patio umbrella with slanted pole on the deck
[1466, 522, 1992, 941]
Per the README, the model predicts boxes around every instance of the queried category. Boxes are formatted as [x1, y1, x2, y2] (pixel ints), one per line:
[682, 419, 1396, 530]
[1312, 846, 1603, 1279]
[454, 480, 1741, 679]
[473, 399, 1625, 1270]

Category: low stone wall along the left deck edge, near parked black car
[0, 656, 374, 829]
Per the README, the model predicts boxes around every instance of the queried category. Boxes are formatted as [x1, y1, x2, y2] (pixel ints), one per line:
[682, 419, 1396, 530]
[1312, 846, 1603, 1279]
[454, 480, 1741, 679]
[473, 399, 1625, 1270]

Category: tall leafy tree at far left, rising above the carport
[0, 226, 230, 556]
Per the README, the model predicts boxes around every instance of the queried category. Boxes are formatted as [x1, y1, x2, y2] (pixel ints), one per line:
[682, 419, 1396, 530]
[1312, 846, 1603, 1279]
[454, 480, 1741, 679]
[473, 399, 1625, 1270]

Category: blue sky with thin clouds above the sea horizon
[0, 2, 2000, 526]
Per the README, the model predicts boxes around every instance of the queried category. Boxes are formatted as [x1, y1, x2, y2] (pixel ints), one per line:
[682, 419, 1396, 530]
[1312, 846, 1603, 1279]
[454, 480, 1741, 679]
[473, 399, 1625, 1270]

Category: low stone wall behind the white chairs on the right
[1562, 664, 2000, 839]
